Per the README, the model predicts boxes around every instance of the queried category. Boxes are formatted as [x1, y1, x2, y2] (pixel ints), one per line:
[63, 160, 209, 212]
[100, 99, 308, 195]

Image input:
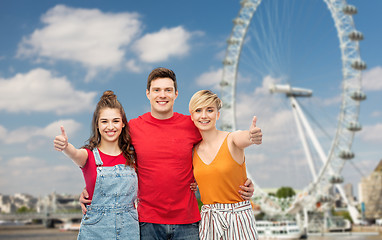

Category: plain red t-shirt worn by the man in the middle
[129, 113, 201, 224]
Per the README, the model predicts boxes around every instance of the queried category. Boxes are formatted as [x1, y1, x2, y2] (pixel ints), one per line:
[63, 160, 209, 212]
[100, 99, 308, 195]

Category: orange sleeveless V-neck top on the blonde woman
[193, 135, 247, 204]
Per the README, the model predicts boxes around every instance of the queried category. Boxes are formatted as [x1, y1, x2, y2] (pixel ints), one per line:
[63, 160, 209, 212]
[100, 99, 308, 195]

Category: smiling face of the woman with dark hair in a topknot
[98, 108, 125, 144]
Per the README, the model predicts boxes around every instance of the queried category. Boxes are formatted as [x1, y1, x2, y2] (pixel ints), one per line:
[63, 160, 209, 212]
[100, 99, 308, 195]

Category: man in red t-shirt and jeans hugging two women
[80, 68, 260, 239]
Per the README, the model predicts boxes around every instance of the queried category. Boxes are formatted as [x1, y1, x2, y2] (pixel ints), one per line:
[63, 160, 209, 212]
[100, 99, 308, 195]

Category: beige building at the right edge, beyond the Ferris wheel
[359, 160, 382, 220]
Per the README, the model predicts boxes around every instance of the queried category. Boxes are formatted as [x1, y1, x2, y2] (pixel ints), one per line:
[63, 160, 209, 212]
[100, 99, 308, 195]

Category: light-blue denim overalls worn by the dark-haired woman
[78, 148, 139, 240]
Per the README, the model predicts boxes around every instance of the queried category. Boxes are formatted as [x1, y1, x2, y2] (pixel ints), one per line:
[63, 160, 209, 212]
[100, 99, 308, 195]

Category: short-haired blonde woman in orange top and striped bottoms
[189, 90, 262, 240]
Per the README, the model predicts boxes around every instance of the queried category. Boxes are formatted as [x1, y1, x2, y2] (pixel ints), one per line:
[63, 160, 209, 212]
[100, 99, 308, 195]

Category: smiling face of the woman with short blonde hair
[191, 104, 220, 131]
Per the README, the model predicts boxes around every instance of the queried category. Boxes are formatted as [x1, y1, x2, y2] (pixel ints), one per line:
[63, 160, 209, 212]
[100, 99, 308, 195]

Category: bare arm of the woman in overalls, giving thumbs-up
[53, 126, 88, 167]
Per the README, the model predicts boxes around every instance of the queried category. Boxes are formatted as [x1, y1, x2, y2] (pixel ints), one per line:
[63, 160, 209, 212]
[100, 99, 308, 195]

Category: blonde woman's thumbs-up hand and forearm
[231, 116, 263, 149]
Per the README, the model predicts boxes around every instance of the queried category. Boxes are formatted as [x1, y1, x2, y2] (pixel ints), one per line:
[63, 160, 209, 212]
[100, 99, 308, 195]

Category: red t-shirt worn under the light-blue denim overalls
[81, 149, 126, 200]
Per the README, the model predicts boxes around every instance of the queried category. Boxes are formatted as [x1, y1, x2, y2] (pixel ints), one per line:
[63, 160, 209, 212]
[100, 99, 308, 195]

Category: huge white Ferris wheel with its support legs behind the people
[220, 0, 366, 222]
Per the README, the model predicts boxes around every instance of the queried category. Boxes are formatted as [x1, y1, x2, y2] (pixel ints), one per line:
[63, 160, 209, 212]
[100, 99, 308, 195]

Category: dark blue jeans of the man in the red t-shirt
[139, 222, 199, 240]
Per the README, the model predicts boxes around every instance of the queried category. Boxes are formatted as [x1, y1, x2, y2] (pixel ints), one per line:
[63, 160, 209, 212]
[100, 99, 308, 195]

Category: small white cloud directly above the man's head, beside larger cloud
[133, 26, 192, 63]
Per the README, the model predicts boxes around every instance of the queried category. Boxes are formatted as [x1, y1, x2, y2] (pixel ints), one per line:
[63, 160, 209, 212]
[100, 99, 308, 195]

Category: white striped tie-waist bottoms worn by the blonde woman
[199, 201, 258, 240]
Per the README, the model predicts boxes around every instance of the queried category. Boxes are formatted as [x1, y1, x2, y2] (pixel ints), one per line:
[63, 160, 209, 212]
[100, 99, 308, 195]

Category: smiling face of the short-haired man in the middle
[146, 78, 178, 119]
